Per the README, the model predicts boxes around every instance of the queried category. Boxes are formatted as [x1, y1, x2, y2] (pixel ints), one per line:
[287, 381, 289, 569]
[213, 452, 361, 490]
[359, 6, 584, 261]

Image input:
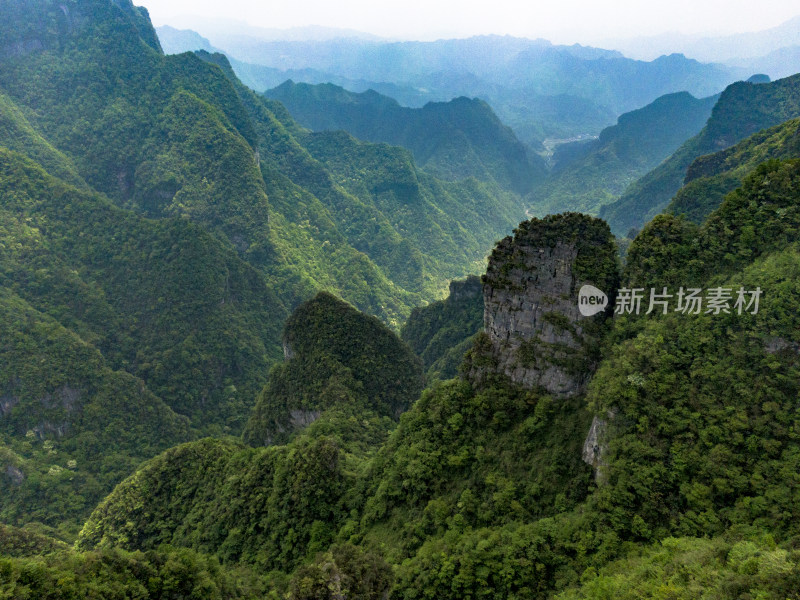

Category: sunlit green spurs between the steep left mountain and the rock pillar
[198, 52, 522, 310]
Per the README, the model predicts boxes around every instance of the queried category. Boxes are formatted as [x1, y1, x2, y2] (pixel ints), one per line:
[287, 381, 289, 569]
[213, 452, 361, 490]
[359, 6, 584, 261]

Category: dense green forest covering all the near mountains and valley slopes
[0, 0, 800, 600]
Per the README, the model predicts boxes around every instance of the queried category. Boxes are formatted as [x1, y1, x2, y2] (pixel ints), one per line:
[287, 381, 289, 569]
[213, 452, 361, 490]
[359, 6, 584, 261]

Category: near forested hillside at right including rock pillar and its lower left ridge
[79, 160, 800, 599]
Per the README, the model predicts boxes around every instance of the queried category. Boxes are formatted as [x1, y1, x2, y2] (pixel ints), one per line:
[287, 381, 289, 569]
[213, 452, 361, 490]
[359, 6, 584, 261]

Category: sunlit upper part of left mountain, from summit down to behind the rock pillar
[0, 0, 532, 329]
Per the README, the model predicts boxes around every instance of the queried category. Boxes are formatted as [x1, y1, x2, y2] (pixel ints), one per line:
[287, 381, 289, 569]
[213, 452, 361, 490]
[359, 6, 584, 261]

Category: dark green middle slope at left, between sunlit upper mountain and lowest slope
[0, 150, 287, 433]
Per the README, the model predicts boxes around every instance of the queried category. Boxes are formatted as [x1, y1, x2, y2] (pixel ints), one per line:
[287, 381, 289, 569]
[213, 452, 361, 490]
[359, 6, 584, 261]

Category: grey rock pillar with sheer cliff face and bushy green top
[468, 213, 617, 396]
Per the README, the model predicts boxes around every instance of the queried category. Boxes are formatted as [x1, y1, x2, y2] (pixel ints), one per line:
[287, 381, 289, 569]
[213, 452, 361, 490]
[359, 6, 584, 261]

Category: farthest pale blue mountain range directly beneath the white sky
[164, 33, 743, 150]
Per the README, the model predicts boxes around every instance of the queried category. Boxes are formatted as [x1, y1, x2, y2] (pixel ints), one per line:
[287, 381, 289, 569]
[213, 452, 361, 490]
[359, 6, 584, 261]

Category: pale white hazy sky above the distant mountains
[144, 0, 800, 43]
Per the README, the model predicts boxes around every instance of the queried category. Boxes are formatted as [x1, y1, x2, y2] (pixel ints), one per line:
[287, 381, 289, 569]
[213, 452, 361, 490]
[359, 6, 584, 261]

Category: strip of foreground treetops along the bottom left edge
[0, 525, 393, 600]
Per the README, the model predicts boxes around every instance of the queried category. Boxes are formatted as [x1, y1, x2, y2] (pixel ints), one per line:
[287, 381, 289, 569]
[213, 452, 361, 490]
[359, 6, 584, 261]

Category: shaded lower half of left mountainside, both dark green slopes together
[0, 144, 294, 533]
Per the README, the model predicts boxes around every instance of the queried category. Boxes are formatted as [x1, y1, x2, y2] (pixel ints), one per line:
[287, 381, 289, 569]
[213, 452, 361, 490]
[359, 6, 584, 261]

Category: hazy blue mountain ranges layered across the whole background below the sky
[159, 20, 800, 241]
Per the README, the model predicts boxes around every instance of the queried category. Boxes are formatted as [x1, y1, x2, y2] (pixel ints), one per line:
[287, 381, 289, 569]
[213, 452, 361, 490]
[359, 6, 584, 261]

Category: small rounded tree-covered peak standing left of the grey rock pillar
[243, 292, 422, 445]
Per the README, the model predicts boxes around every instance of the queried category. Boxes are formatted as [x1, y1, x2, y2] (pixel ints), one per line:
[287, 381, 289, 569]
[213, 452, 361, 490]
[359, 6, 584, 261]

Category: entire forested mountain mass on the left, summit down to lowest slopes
[0, 0, 522, 541]
